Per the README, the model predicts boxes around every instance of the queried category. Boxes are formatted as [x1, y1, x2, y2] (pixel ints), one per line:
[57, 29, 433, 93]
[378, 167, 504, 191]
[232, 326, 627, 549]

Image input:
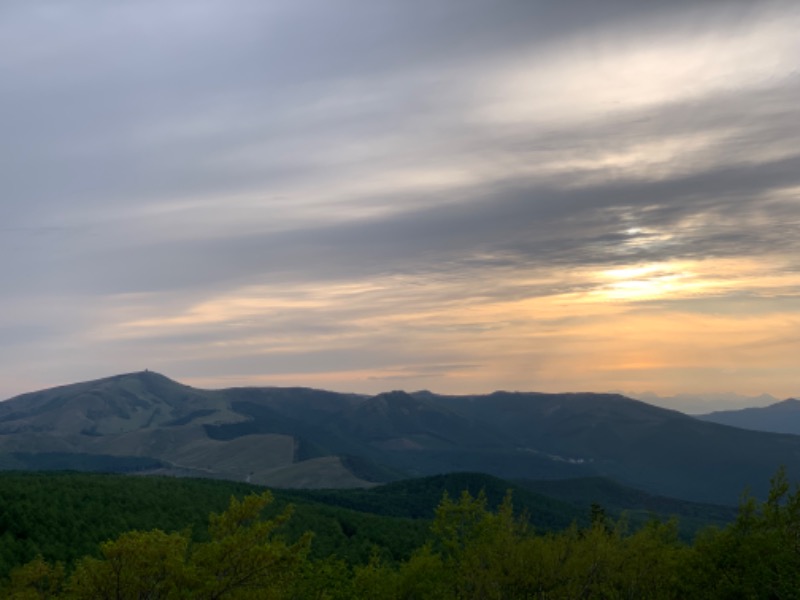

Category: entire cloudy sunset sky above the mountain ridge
[0, 0, 800, 408]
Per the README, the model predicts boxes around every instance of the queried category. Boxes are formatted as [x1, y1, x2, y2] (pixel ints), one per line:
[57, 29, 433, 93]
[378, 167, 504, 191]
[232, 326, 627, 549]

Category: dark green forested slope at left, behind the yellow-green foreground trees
[0, 472, 441, 577]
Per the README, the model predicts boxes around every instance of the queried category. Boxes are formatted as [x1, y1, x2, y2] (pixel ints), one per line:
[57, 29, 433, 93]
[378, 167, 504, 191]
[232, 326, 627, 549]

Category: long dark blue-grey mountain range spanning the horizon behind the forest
[0, 371, 800, 505]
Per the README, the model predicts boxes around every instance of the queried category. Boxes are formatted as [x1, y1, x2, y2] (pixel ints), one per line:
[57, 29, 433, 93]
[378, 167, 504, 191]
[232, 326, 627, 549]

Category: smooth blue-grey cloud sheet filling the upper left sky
[2, 2, 784, 211]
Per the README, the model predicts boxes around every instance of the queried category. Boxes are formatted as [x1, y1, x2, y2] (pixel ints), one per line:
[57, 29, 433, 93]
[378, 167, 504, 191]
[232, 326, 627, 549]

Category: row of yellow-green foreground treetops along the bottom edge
[1, 470, 800, 600]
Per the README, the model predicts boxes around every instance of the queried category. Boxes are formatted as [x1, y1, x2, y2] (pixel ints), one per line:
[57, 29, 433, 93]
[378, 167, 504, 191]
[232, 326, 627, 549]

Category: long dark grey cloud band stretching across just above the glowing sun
[42, 139, 800, 293]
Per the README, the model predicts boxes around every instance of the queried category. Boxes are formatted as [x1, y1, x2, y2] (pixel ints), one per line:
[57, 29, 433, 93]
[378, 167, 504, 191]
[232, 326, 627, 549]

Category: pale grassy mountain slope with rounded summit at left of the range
[0, 371, 376, 487]
